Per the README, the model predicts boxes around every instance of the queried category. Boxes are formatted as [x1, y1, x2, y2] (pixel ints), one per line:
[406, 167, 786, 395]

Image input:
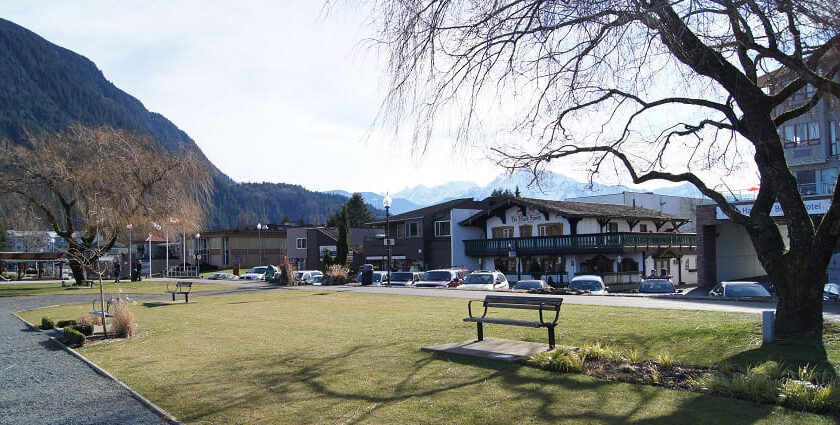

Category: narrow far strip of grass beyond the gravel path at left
[0, 280, 243, 297]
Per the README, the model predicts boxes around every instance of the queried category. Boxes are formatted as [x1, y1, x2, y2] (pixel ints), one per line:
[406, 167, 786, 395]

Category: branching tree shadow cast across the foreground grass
[162, 345, 800, 425]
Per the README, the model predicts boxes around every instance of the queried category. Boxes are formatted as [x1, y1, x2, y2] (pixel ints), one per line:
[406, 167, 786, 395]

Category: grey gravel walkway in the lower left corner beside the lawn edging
[0, 295, 169, 424]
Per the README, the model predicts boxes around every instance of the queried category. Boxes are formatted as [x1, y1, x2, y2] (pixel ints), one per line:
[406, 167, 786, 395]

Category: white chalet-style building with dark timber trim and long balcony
[458, 197, 696, 284]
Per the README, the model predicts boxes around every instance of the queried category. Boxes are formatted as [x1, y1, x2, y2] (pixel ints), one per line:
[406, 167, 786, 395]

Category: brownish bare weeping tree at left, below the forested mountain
[0, 125, 211, 283]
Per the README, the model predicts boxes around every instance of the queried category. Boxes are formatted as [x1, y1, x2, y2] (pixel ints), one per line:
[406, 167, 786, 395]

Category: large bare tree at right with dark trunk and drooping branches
[374, 0, 840, 339]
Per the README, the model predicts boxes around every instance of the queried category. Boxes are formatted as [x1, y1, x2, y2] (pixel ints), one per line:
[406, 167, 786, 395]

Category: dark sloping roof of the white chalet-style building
[460, 197, 691, 226]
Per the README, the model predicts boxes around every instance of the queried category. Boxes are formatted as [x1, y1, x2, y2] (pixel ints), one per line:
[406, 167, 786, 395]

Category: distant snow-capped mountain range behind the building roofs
[325, 171, 703, 214]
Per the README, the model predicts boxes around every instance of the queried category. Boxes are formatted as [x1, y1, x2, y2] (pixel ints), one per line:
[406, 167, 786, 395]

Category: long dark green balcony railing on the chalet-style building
[464, 233, 697, 256]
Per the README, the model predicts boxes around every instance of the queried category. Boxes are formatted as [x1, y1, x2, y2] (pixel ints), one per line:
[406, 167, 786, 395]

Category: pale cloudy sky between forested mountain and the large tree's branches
[0, 0, 502, 193]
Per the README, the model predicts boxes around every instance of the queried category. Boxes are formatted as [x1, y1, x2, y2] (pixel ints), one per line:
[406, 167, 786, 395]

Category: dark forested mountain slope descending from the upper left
[0, 19, 358, 229]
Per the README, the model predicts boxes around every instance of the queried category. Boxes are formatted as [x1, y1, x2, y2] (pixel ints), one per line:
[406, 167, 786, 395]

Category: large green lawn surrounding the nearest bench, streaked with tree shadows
[22, 290, 840, 424]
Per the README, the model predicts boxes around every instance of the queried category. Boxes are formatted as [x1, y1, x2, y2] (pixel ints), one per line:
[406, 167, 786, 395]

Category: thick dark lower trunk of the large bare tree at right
[770, 259, 826, 343]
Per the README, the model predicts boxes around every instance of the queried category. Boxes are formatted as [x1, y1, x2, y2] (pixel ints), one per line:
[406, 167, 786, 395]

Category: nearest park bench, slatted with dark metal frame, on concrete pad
[464, 295, 563, 348]
